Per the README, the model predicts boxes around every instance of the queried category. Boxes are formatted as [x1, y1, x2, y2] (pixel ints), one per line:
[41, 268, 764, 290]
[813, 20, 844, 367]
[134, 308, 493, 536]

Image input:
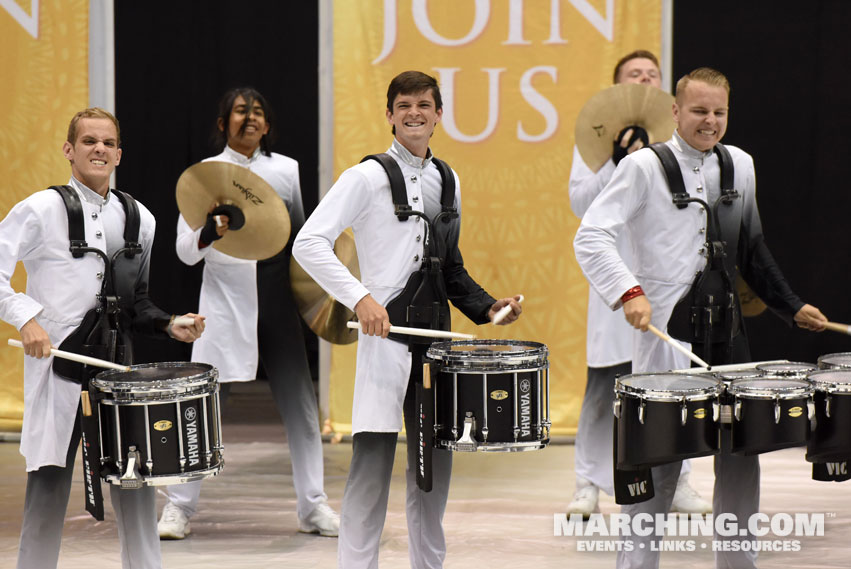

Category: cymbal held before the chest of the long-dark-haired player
[177, 162, 290, 260]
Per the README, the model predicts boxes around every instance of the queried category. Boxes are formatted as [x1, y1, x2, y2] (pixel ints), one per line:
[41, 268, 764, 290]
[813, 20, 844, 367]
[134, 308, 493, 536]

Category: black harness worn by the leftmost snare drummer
[50, 186, 142, 389]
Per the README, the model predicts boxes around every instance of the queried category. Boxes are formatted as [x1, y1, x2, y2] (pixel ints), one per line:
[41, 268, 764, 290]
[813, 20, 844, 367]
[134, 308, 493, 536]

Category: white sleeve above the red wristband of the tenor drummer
[573, 157, 649, 310]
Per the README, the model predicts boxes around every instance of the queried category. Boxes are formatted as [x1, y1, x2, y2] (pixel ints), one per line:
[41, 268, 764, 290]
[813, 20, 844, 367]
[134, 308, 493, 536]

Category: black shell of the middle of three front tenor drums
[731, 397, 810, 455]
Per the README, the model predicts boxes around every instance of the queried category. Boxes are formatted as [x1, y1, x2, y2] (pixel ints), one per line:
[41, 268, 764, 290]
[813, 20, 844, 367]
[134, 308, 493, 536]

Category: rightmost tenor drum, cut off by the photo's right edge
[807, 370, 851, 462]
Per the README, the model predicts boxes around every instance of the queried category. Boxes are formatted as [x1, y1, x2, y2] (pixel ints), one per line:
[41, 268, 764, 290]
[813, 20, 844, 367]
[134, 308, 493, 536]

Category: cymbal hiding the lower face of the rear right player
[575, 83, 677, 172]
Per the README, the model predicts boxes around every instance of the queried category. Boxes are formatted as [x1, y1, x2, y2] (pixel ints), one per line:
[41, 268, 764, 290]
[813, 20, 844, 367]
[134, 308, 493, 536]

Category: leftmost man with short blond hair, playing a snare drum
[0, 108, 204, 569]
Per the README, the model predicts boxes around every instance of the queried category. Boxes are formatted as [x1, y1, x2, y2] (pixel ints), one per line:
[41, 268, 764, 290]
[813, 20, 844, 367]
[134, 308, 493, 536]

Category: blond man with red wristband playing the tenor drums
[574, 67, 827, 569]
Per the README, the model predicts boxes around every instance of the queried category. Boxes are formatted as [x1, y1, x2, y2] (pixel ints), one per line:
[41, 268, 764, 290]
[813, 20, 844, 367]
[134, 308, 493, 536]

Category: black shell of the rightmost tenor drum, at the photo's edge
[807, 390, 851, 462]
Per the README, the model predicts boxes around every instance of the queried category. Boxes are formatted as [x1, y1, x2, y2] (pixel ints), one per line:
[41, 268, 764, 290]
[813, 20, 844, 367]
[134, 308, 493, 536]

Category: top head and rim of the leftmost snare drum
[91, 362, 218, 401]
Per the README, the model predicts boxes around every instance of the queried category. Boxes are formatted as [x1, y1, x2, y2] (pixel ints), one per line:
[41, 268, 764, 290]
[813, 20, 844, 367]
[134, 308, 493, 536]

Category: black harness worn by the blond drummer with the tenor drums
[650, 142, 741, 364]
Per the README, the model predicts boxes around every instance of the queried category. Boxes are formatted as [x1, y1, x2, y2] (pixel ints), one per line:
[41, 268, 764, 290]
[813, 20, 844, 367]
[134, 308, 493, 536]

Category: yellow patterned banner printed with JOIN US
[331, 0, 662, 434]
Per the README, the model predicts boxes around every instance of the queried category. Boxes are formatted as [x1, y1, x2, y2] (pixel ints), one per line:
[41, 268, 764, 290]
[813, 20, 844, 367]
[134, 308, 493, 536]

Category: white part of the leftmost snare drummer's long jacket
[0, 177, 155, 472]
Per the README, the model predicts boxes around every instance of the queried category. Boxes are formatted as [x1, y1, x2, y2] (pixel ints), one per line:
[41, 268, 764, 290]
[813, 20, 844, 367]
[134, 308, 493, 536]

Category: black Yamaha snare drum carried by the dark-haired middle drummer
[426, 340, 550, 451]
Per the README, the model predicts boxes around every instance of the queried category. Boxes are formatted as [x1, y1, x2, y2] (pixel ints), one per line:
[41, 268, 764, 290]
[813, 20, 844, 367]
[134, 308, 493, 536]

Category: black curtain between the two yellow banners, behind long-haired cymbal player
[115, 0, 319, 361]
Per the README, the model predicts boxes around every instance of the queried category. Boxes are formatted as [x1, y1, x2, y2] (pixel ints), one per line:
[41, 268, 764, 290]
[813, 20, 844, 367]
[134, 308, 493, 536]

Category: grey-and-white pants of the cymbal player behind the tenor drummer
[574, 362, 691, 496]
